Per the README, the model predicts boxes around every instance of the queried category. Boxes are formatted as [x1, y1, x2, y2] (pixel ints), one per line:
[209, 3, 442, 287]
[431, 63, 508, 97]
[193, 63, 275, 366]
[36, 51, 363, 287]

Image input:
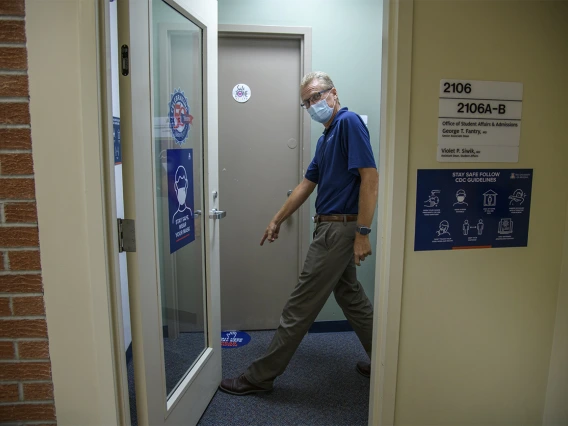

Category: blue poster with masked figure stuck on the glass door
[167, 149, 195, 253]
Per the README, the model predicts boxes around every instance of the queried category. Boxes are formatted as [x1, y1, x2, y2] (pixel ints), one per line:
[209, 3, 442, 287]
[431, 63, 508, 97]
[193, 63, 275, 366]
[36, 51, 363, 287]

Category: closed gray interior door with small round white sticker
[219, 37, 302, 330]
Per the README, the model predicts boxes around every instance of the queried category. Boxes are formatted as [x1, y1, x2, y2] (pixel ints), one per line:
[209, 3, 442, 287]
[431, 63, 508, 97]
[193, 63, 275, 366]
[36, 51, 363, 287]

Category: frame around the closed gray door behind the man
[218, 24, 312, 275]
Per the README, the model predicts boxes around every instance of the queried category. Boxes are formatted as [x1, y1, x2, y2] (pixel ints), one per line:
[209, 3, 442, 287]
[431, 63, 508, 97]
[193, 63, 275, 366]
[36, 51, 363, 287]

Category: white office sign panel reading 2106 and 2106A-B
[437, 80, 523, 163]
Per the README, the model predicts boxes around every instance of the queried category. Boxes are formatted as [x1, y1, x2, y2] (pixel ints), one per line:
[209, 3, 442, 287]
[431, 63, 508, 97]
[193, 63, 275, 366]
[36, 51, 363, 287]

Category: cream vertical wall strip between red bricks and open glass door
[26, 0, 119, 426]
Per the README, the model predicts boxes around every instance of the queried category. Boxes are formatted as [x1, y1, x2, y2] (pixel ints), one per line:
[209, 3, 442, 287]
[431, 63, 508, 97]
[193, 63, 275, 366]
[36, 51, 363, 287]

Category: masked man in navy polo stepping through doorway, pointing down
[219, 72, 379, 395]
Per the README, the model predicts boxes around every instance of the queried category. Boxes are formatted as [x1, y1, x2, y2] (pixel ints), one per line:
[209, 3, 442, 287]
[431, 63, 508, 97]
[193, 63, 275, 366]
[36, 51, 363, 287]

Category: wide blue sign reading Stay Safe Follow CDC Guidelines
[414, 169, 533, 251]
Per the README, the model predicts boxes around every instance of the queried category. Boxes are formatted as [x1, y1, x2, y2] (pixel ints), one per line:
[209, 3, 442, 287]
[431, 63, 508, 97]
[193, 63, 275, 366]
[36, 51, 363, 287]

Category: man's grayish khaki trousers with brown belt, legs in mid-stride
[245, 222, 373, 389]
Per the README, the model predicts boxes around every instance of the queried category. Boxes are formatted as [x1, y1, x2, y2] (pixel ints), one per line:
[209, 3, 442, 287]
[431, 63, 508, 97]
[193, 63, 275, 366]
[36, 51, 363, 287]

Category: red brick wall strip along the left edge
[0, 0, 55, 425]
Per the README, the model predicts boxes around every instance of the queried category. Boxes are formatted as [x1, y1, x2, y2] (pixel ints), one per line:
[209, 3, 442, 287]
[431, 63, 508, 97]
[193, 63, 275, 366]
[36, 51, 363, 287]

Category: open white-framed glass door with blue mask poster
[118, 0, 224, 425]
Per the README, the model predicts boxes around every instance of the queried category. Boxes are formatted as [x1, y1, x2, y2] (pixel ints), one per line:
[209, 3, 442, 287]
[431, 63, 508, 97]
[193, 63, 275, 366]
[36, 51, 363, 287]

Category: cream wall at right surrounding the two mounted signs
[395, 0, 568, 426]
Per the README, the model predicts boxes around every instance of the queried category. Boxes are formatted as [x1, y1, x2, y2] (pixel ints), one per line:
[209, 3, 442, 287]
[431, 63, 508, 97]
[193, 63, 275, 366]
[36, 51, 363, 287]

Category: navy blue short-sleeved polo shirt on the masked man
[306, 108, 377, 215]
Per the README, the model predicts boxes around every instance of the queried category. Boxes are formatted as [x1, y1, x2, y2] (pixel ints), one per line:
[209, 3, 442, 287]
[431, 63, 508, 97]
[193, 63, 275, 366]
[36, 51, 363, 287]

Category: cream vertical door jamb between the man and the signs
[369, 0, 414, 426]
